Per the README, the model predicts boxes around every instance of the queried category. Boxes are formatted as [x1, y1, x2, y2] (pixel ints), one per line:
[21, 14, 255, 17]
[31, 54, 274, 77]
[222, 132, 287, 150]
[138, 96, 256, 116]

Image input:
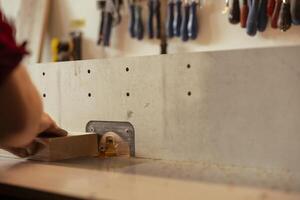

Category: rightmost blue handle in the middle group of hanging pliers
[188, 0, 198, 40]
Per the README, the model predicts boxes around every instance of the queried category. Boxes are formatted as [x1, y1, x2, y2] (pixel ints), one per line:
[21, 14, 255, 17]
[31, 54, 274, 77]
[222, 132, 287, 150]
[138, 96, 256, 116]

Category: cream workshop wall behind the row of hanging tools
[2, 0, 300, 62]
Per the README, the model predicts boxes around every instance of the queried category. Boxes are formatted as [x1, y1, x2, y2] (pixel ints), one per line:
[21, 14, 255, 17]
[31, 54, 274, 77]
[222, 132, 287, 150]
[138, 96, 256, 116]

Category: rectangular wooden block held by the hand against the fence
[29, 134, 98, 161]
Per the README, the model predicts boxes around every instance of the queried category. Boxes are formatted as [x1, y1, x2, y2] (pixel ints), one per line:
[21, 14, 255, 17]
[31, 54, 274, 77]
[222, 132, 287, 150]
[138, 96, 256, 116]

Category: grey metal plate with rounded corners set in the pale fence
[86, 121, 135, 157]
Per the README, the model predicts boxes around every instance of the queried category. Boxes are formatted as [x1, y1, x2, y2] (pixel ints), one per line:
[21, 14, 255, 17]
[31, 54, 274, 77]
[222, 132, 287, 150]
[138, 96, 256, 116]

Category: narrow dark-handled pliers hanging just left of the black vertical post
[148, 0, 161, 39]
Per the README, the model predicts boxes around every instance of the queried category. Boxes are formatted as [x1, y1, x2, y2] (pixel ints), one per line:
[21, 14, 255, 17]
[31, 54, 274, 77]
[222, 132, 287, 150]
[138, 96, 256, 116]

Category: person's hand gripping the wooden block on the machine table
[2, 113, 68, 158]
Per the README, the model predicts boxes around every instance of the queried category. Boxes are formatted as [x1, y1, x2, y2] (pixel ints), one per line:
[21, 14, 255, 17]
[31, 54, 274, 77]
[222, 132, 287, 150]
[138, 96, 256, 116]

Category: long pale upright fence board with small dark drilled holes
[30, 47, 300, 190]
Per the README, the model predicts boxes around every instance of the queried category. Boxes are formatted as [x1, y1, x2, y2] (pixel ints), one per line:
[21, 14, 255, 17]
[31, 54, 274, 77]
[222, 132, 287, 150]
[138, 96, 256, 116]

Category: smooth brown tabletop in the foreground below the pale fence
[0, 157, 300, 200]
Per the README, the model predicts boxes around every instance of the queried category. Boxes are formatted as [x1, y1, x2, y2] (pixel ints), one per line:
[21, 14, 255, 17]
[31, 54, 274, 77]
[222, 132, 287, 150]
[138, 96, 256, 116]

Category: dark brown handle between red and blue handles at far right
[278, 0, 292, 31]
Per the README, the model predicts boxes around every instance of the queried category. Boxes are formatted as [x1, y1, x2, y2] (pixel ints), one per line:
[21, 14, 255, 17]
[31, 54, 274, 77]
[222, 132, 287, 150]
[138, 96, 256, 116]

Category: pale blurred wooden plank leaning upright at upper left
[16, 0, 50, 64]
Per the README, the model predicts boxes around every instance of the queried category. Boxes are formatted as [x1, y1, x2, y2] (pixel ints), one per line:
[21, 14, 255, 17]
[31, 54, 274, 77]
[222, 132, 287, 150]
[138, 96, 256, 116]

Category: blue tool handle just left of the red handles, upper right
[257, 0, 268, 32]
